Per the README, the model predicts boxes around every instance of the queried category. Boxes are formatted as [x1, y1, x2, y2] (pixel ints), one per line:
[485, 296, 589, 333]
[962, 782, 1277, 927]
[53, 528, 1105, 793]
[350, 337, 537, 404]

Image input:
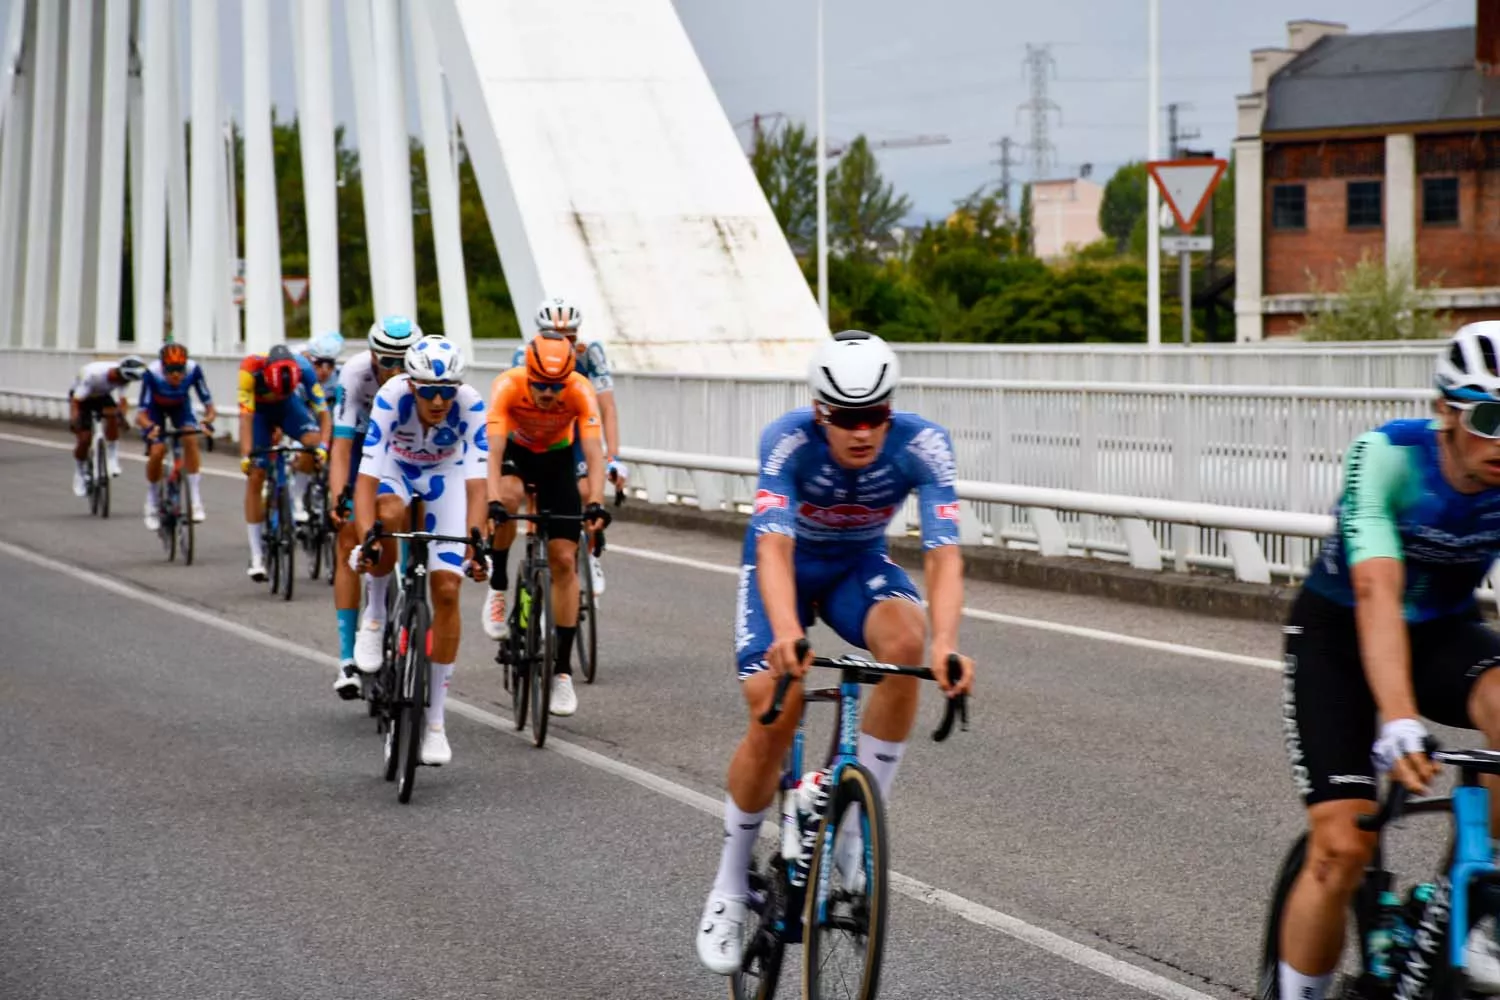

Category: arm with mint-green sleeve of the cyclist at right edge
[1338, 430, 1418, 721]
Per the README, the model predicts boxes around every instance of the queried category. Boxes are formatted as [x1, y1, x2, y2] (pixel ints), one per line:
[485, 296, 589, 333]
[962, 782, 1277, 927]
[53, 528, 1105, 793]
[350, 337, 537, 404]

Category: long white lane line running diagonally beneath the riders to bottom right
[0, 539, 1214, 1000]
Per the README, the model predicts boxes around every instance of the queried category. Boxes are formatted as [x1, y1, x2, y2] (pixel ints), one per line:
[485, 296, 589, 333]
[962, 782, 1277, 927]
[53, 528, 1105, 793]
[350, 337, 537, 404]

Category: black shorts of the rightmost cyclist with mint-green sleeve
[1281, 588, 1500, 805]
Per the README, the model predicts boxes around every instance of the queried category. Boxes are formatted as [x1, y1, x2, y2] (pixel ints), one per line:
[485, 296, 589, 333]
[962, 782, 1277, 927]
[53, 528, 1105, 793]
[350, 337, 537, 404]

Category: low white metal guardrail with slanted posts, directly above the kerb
[621, 448, 1335, 583]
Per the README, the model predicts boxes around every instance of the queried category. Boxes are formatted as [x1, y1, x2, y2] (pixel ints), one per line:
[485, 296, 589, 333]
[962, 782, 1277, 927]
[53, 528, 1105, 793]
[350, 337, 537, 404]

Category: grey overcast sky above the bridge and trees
[0, 0, 1479, 216]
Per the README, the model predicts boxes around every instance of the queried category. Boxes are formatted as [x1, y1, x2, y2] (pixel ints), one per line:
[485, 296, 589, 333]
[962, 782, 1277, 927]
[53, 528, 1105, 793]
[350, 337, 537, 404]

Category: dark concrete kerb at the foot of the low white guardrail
[611, 501, 1298, 622]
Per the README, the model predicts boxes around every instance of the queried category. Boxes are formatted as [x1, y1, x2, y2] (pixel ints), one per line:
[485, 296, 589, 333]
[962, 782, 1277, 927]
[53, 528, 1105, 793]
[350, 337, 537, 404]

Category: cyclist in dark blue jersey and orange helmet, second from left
[135, 343, 215, 531]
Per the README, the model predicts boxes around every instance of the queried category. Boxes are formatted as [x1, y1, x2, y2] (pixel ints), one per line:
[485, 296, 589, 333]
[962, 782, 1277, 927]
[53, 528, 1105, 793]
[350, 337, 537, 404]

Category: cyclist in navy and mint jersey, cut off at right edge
[1280, 321, 1500, 1000]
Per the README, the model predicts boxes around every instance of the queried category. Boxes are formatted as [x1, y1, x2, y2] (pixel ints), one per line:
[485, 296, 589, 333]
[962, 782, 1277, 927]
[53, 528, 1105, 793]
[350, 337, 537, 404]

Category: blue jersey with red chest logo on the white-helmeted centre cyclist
[746, 408, 959, 561]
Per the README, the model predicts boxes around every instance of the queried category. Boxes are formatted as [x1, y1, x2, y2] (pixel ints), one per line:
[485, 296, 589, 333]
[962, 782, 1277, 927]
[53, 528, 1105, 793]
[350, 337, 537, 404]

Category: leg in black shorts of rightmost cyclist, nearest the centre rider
[1280, 591, 1376, 1000]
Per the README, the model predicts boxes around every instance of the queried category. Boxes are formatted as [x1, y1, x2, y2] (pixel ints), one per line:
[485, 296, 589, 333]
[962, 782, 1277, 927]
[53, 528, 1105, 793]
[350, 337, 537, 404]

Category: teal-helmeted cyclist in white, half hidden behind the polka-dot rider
[329, 316, 422, 700]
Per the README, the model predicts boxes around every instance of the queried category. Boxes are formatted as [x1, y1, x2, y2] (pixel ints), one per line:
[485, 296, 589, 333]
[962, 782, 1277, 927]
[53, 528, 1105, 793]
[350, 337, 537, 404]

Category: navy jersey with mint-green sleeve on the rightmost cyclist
[1307, 420, 1500, 622]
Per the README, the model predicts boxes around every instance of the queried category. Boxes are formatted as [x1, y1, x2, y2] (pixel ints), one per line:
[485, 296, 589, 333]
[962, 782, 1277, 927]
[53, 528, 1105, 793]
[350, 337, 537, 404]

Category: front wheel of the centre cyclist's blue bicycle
[803, 765, 888, 1000]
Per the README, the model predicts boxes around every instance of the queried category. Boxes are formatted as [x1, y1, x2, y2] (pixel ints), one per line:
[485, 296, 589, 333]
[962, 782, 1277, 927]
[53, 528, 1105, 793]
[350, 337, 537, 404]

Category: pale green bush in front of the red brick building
[1299, 250, 1451, 340]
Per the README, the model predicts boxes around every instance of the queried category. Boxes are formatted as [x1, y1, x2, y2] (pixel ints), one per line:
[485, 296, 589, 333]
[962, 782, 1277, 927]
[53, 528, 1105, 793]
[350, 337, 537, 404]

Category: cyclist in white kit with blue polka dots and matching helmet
[354, 337, 489, 765]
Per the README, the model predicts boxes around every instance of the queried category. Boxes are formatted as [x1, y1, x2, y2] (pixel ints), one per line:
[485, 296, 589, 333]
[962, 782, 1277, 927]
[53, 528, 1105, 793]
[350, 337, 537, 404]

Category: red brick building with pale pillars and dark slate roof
[1235, 12, 1500, 342]
